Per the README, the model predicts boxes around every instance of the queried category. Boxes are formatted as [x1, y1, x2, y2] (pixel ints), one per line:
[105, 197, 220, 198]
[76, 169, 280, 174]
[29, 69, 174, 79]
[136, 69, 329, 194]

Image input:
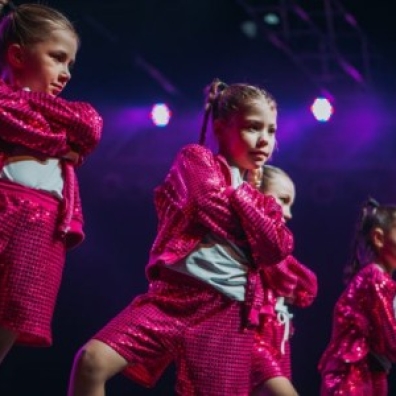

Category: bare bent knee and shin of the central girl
[68, 340, 128, 396]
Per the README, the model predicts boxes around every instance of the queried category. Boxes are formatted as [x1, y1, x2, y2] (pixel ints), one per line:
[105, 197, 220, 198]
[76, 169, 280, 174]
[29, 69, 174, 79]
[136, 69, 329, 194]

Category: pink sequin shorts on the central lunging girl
[94, 270, 253, 396]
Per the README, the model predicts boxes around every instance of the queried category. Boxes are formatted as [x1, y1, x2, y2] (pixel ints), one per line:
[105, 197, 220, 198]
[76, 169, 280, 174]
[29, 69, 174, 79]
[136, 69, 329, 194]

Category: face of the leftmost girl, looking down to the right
[9, 29, 78, 96]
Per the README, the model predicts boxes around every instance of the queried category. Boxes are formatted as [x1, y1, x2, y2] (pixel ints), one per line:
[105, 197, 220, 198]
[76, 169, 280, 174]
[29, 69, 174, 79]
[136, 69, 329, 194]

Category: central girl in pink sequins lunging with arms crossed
[69, 80, 293, 396]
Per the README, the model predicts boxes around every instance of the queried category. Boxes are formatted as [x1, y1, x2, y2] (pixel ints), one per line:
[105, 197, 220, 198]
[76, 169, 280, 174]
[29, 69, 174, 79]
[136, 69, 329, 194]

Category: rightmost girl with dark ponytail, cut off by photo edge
[319, 200, 396, 396]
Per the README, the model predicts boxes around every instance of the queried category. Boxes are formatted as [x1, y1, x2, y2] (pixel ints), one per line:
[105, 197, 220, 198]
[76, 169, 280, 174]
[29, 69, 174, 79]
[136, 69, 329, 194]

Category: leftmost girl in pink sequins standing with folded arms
[0, 1, 102, 361]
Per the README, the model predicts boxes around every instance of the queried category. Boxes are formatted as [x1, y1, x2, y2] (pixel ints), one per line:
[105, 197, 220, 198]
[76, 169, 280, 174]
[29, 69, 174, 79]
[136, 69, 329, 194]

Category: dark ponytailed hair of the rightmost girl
[344, 198, 396, 283]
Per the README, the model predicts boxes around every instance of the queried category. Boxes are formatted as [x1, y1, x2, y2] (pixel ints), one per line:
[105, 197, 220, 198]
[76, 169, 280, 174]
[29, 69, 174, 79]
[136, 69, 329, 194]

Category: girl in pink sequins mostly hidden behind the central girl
[248, 165, 318, 396]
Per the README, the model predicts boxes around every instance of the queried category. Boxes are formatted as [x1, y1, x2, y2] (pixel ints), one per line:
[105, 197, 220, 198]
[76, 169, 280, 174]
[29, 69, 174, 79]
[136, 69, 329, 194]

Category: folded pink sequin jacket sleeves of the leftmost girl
[0, 80, 102, 157]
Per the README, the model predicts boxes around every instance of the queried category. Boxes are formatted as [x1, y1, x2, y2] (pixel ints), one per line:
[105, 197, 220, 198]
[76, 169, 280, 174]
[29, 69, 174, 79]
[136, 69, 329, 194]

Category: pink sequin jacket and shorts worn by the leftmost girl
[0, 80, 102, 346]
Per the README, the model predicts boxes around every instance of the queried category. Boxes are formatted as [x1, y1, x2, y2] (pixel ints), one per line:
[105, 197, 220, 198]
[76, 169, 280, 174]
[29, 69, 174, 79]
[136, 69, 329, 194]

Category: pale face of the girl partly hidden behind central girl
[264, 173, 296, 221]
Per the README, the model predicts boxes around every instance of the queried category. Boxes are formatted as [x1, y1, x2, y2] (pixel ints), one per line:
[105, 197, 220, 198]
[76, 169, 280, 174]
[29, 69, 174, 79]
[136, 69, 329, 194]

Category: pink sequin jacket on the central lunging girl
[146, 144, 293, 325]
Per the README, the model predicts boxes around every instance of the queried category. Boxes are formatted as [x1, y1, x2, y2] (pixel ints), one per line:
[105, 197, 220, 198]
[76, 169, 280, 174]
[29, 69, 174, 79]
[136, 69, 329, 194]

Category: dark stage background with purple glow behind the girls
[0, 0, 396, 396]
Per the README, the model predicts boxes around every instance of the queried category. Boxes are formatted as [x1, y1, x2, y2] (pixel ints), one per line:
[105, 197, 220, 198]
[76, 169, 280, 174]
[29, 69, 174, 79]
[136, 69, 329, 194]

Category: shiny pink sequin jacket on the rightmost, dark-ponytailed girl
[319, 264, 396, 374]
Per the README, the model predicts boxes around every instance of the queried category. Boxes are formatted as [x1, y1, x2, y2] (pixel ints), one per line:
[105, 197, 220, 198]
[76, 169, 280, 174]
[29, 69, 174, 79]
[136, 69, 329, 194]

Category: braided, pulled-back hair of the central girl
[199, 78, 276, 145]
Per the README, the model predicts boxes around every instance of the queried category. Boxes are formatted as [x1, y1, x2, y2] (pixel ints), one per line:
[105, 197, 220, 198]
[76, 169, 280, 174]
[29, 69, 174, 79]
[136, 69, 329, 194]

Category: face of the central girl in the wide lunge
[215, 98, 277, 171]
